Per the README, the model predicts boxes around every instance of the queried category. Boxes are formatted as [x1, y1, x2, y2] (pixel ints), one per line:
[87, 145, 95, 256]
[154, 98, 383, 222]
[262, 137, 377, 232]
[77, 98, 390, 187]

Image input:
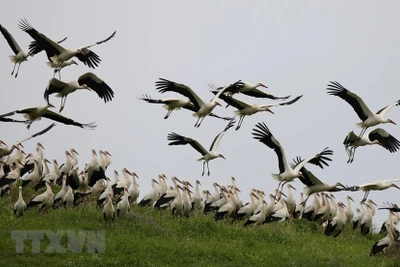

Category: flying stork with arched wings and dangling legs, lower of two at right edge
[343, 128, 400, 163]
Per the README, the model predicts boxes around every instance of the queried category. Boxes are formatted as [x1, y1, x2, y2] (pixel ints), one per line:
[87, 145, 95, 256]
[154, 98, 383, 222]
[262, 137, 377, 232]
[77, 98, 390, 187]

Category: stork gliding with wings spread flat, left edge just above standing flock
[0, 103, 97, 129]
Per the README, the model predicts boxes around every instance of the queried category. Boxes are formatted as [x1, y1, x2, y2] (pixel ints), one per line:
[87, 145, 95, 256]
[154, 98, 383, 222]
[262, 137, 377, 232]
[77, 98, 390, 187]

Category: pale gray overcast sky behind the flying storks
[0, 1, 400, 228]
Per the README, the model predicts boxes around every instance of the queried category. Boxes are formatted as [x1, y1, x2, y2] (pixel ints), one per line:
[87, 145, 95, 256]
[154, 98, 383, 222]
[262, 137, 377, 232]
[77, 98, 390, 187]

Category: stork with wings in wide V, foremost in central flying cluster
[156, 78, 241, 128]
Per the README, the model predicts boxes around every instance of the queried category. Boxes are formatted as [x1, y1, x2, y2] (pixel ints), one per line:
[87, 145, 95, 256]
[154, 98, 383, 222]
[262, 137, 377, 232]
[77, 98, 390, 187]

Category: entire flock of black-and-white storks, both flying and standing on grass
[0, 19, 400, 256]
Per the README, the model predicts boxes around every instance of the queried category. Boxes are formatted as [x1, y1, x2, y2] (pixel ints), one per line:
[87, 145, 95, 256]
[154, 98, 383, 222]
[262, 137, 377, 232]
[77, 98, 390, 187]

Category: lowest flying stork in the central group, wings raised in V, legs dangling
[167, 120, 235, 176]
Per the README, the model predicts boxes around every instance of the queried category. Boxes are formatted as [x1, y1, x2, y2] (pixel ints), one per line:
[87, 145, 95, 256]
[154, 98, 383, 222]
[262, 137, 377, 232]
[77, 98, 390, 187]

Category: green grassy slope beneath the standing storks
[0, 185, 400, 267]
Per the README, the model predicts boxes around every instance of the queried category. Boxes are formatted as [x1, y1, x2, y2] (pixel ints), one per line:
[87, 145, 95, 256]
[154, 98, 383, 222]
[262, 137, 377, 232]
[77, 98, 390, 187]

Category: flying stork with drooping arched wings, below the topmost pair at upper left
[44, 72, 114, 112]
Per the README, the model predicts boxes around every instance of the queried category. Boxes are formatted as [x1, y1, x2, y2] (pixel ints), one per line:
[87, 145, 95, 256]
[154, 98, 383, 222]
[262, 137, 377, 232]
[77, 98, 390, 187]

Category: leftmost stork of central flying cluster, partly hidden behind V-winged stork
[139, 95, 232, 120]
